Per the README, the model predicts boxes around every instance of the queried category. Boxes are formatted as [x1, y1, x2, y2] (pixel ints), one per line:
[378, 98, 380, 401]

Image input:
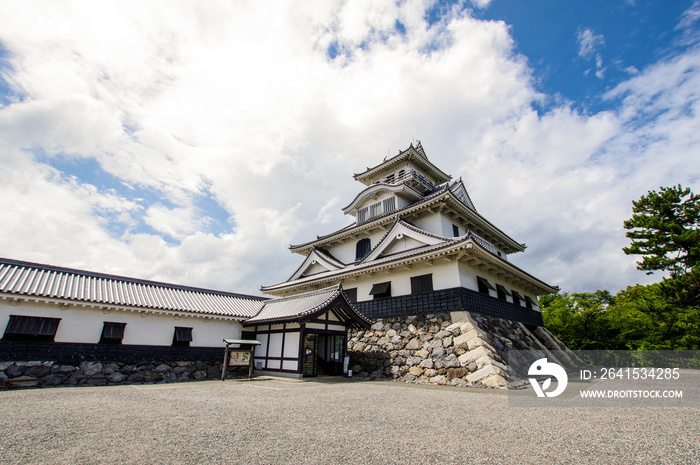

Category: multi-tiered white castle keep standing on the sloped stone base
[261, 142, 558, 325]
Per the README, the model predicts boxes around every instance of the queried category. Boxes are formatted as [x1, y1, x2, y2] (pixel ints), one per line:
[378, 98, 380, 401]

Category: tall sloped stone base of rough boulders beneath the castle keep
[348, 312, 566, 387]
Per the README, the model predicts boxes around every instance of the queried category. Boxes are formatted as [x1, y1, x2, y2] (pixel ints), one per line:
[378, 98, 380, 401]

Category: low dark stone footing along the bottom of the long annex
[0, 361, 248, 387]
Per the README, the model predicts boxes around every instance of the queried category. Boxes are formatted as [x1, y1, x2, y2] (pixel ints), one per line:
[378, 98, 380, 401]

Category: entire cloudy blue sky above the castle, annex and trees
[0, 0, 700, 294]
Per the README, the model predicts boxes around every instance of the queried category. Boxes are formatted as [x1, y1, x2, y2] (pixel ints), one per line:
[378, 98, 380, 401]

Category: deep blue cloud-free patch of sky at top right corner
[477, 0, 695, 112]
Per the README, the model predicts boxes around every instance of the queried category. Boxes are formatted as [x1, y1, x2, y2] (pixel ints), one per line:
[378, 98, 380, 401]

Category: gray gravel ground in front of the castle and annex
[0, 378, 700, 465]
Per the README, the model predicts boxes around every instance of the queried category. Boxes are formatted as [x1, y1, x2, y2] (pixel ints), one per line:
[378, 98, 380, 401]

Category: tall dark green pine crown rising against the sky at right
[622, 184, 700, 276]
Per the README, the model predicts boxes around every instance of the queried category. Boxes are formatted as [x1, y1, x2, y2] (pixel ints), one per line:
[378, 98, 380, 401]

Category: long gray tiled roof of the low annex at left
[0, 258, 268, 318]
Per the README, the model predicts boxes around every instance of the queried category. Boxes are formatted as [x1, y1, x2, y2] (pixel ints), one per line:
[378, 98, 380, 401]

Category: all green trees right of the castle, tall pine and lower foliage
[540, 185, 700, 350]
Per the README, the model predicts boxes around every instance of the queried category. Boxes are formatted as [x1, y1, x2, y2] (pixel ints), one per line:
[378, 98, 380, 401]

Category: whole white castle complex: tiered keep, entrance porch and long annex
[0, 142, 557, 377]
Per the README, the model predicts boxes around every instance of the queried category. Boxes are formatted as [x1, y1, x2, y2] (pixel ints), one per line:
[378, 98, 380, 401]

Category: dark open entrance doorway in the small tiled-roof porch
[302, 333, 345, 377]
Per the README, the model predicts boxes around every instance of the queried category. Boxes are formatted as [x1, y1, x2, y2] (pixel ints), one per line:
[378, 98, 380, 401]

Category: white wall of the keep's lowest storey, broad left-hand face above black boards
[343, 261, 460, 302]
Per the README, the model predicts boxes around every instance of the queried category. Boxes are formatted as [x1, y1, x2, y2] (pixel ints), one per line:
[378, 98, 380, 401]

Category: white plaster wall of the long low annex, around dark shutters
[0, 299, 242, 347]
